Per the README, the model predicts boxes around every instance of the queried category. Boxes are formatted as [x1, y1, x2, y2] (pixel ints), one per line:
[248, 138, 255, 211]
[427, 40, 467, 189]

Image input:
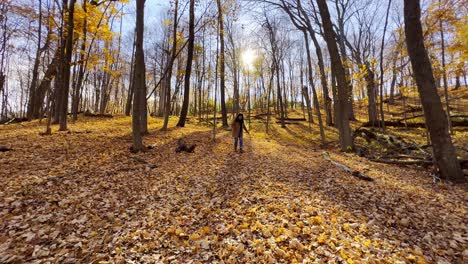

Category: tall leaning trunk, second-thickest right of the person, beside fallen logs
[317, 0, 353, 151]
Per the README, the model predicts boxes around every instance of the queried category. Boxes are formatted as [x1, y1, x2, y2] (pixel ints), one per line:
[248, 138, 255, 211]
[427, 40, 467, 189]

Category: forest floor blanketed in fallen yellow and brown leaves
[0, 117, 468, 263]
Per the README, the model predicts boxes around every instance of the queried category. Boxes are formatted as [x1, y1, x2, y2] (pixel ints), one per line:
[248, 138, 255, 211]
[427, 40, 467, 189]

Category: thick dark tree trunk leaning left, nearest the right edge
[404, 0, 464, 182]
